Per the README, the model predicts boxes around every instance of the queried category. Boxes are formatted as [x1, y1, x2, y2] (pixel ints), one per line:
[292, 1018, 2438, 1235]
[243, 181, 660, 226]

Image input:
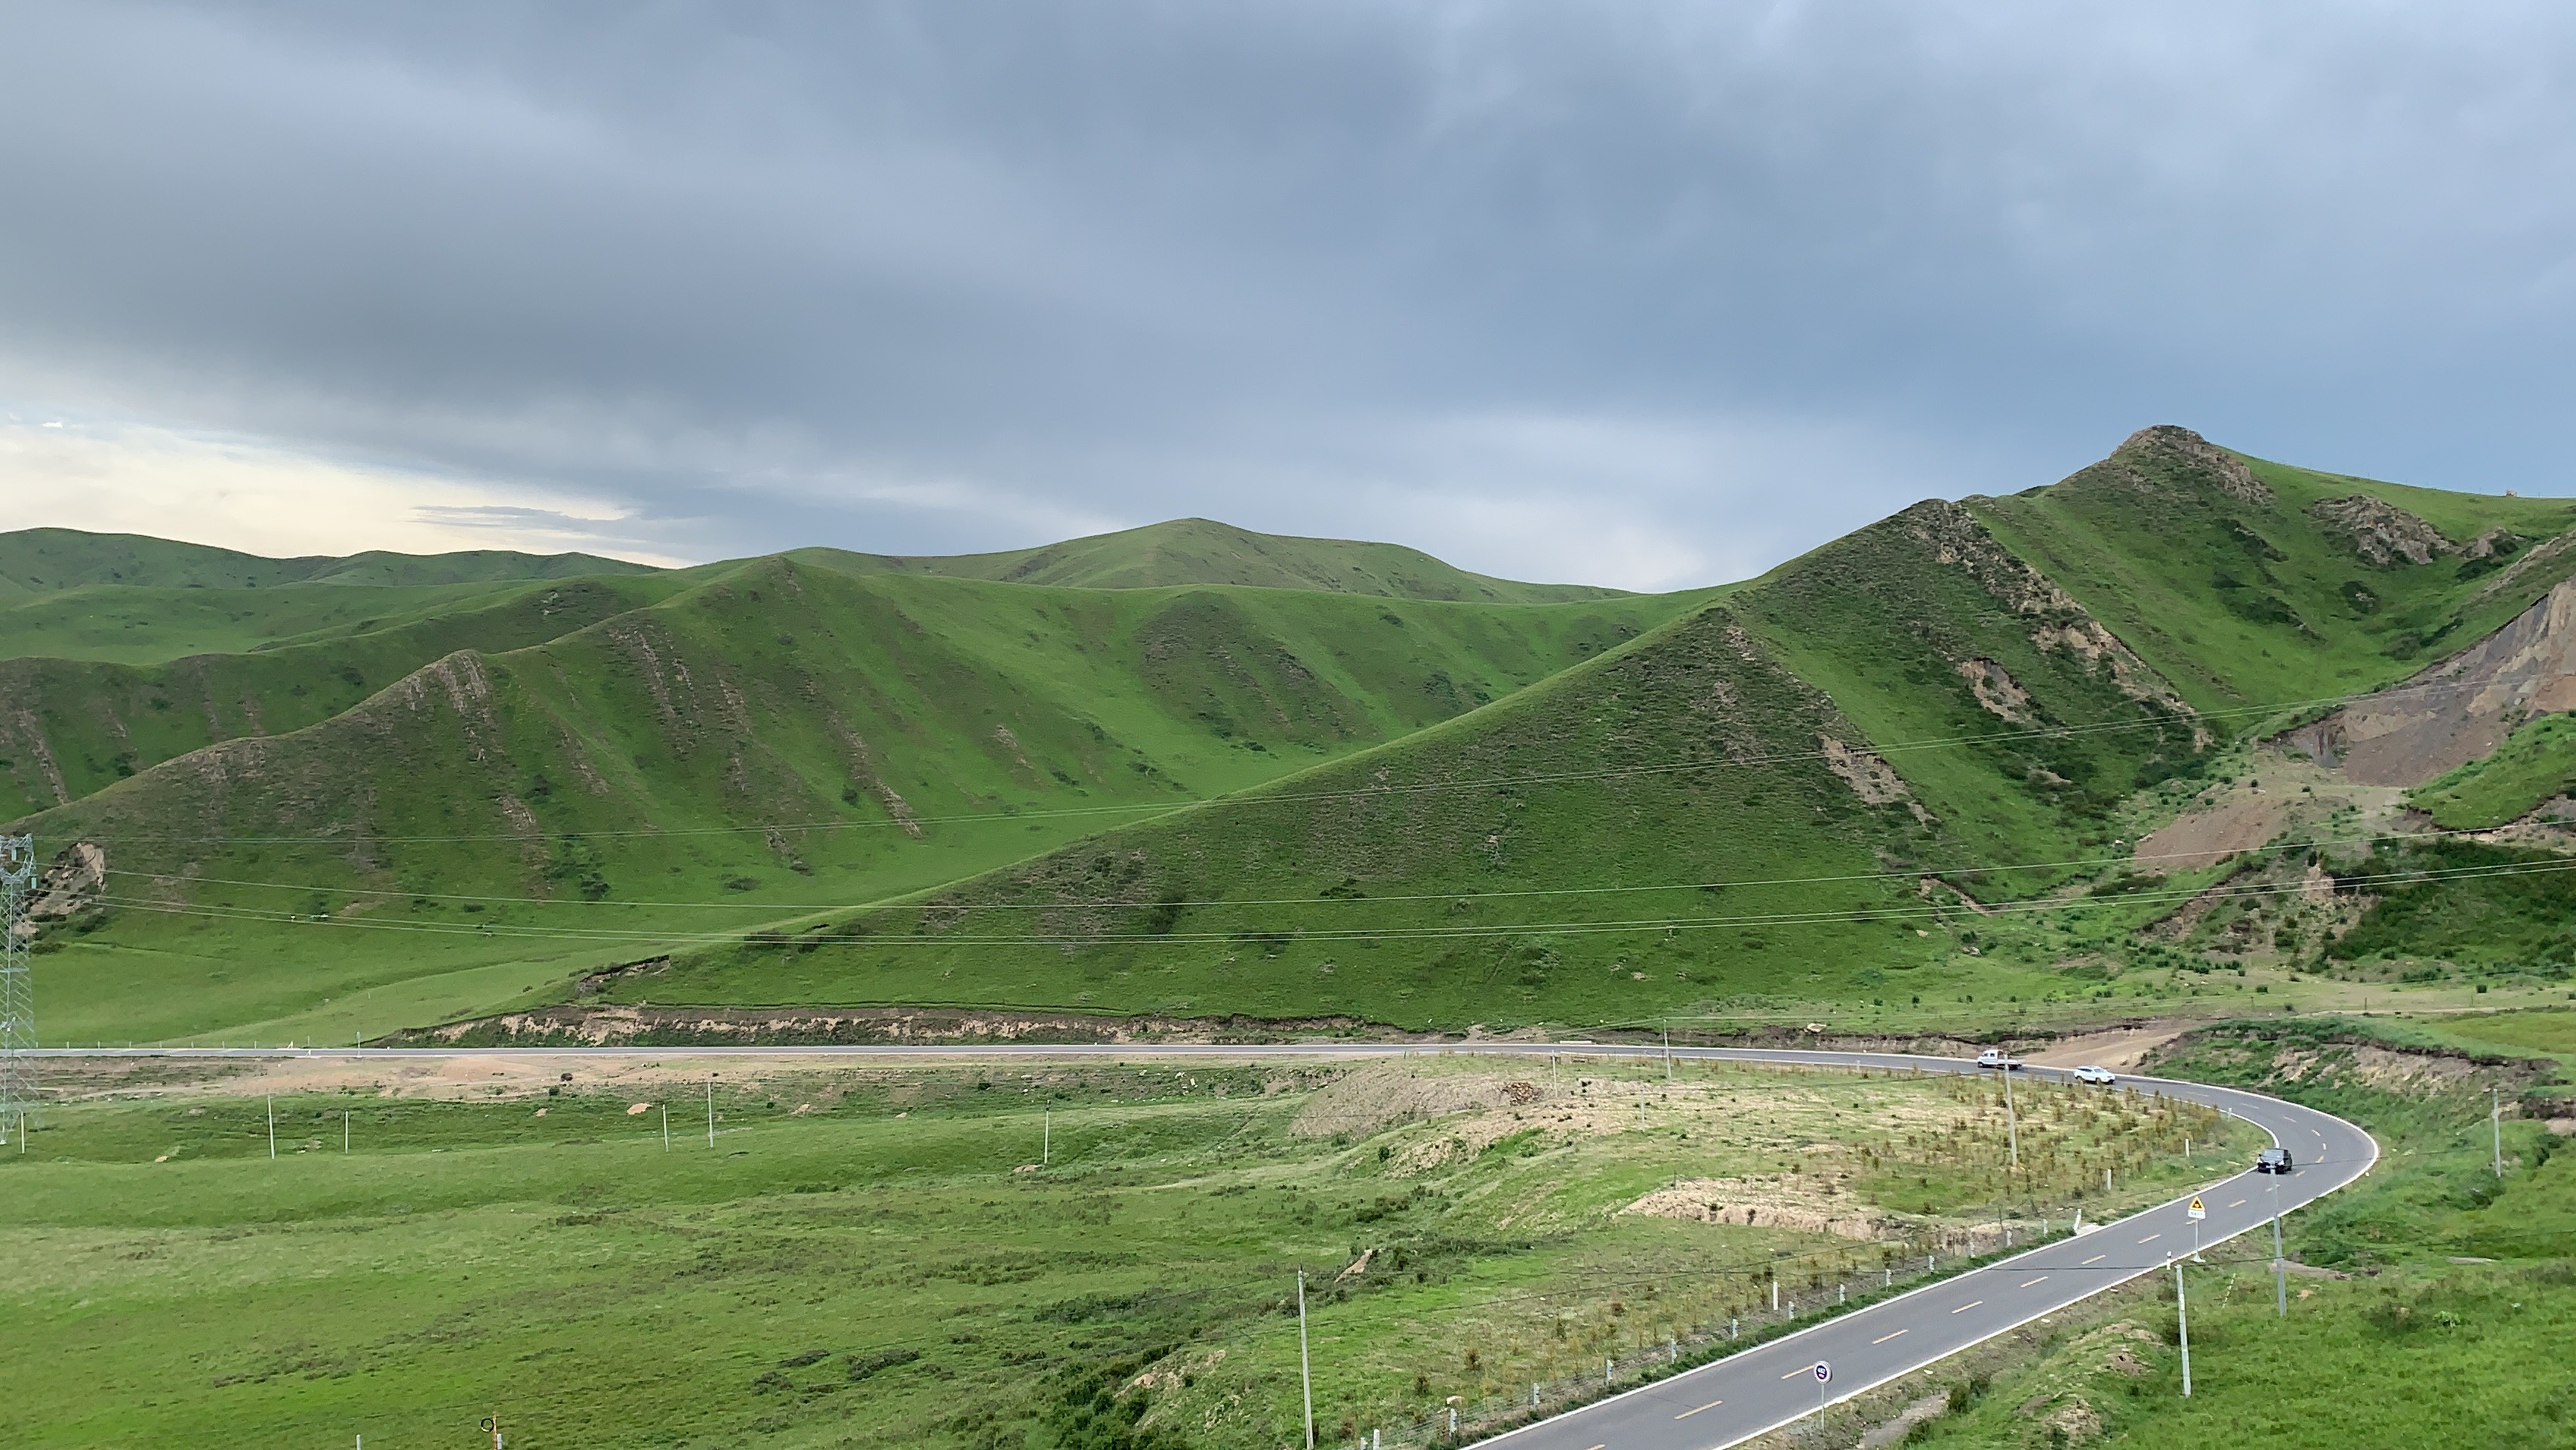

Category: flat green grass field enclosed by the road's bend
[0, 1056, 2251, 1448]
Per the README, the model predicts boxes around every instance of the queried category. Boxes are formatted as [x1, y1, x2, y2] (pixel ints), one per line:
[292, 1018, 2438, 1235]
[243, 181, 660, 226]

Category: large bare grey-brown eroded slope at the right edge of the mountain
[2282, 579, 2576, 785]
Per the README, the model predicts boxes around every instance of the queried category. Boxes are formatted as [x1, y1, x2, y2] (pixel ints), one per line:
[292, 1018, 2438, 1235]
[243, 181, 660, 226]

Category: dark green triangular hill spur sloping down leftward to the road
[623, 594, 1950, 1028]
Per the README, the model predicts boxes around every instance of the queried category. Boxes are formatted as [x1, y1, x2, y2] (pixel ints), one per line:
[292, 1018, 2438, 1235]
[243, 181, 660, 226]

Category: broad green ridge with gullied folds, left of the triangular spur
[11, 557, 1690, 1035]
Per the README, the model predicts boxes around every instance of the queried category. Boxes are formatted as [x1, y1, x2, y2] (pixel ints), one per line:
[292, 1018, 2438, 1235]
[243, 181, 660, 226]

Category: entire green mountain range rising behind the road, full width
[0, 427, 2576, 1038]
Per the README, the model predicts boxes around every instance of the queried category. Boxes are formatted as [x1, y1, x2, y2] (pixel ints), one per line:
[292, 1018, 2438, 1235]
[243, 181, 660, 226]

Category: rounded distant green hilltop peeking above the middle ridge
[806, 517, 1620, 605]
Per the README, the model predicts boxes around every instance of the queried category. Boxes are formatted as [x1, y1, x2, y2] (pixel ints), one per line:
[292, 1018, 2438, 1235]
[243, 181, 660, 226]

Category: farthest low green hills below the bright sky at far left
[0, 528, 652, 597]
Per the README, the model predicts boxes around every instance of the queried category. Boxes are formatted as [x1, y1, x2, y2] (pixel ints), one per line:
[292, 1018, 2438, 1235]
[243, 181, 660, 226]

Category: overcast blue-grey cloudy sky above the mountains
[0, 0, 2576, 590]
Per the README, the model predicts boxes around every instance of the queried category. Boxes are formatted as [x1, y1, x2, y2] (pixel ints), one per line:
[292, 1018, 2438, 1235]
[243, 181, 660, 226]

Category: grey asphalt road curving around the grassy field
[42, 1043, 2380, 1450]
